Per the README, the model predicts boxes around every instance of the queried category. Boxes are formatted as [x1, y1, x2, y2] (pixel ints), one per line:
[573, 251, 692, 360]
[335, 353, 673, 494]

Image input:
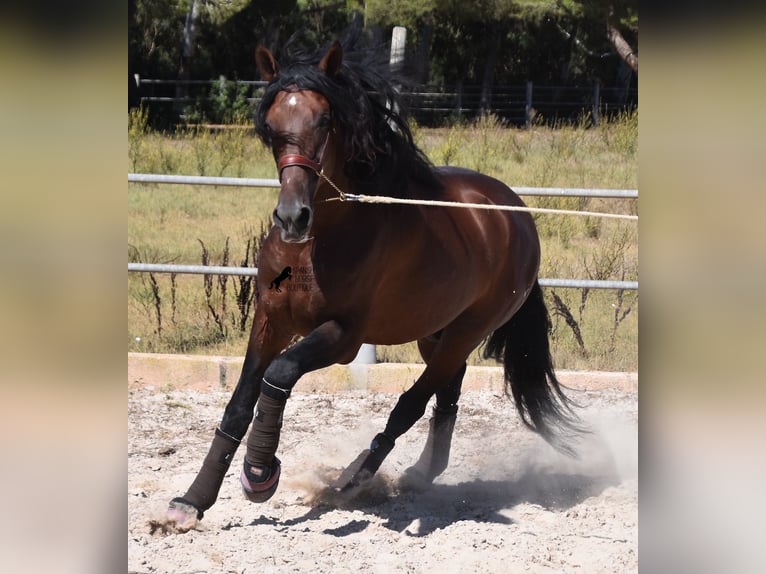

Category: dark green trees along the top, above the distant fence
[128, 0, 638, 117]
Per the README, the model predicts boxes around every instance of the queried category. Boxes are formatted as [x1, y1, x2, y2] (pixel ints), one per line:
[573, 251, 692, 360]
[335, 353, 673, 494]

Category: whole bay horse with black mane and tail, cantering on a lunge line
[167, 41, 584, 528]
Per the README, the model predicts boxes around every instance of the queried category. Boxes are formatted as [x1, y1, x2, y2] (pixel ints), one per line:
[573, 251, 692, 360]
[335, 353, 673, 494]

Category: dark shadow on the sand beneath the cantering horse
[250, 470, 619, 537]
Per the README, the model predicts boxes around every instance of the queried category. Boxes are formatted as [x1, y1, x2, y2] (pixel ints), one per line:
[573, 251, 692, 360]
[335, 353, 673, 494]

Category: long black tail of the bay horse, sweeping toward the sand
[483, 281, 588, 456]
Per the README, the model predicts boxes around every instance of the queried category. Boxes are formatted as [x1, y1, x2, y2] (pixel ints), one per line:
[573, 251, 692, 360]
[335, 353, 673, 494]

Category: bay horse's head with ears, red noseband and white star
[255, 42, 343, 243]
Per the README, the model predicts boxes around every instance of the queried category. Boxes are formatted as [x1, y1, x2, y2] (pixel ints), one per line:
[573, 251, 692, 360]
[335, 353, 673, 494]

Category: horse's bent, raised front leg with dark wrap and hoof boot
[241, 321, 360, 502]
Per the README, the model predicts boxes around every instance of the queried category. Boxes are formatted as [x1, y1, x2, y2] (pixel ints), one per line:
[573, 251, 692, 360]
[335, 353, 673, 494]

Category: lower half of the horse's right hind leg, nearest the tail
[405, 338, 467, 482]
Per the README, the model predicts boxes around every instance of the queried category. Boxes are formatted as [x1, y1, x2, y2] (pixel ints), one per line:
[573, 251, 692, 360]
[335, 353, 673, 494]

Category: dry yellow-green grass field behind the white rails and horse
[127, 113, 638, 370]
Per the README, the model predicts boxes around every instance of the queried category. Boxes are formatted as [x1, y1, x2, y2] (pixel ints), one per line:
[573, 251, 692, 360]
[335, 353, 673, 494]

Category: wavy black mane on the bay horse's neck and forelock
[255, 38, 441, 197]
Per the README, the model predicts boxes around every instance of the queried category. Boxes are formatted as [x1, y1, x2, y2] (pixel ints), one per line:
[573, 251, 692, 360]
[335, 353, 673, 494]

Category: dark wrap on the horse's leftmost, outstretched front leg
[180, 429, 239, 518]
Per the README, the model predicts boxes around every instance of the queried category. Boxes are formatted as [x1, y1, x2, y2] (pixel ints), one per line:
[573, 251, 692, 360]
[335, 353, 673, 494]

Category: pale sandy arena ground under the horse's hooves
[128, 385, 638, 574]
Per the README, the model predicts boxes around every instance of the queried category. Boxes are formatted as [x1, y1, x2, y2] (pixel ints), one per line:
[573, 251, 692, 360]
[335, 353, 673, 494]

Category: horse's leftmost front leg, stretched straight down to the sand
[166, 312, 290, 530]
